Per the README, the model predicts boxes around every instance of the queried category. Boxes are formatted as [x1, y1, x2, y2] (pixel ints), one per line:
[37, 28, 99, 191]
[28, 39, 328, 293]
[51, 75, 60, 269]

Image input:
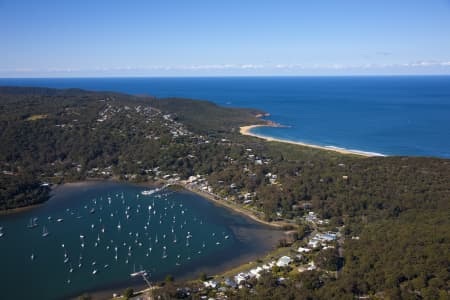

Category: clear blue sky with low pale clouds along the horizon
[0, 0, 450, 77]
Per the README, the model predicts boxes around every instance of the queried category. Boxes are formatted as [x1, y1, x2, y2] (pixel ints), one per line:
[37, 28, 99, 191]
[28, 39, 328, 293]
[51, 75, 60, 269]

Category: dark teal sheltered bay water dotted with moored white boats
[0, 182, 280, 299]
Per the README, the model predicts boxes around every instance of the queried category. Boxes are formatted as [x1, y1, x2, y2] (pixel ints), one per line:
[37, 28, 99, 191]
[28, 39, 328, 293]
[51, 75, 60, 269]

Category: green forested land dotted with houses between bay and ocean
[0, 87, 450, 299]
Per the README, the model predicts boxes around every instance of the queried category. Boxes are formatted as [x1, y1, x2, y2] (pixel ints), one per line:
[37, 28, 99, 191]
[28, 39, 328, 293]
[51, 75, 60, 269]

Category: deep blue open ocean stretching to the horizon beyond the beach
[0, 76, 450, 158]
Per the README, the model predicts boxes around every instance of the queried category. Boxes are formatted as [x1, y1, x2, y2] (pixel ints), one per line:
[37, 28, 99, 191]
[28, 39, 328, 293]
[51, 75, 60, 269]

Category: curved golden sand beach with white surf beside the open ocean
[239, 124, 385, 157]
